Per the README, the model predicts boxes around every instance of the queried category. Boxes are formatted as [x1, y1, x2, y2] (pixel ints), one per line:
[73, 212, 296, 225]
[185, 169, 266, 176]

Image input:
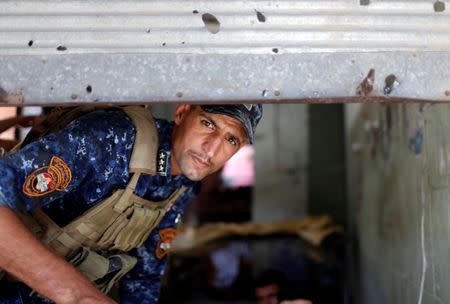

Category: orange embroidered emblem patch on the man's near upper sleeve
[22, 156, 72, 196]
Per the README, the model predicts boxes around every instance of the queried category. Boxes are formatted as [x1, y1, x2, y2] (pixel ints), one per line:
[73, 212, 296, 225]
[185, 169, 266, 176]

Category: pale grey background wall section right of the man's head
[252, 104, 308, 222]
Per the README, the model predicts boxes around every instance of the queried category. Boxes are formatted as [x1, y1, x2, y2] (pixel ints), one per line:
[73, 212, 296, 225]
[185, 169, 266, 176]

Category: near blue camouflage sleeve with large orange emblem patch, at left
[0, 111, 134, 211]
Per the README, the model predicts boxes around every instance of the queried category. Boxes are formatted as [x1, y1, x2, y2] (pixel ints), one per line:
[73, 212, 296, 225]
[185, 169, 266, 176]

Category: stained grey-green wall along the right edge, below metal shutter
[347, 104, 450, 304]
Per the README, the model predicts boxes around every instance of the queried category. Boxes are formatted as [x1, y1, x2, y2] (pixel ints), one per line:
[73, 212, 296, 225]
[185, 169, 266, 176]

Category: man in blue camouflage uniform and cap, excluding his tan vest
[0, 104, 262, 304]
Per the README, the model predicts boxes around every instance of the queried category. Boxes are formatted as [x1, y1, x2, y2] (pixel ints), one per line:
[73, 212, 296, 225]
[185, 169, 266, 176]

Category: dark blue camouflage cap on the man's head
[201, 104, 263, 144]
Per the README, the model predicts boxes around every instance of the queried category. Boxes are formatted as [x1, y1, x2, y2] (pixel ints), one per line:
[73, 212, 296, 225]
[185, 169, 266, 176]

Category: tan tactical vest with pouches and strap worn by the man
[11, 107, 185, 293]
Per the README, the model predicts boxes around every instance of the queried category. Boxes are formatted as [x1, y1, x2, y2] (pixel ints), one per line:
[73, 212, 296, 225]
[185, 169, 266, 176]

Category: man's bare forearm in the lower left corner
[0, 206, 116, 304]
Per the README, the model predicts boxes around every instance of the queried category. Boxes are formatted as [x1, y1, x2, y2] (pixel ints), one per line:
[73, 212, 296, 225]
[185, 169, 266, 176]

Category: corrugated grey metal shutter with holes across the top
[0, 0, 450, 104]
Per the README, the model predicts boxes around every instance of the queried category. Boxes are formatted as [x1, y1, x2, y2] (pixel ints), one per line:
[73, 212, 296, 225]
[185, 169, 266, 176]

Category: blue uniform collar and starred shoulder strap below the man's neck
[155, 118, 195, 187]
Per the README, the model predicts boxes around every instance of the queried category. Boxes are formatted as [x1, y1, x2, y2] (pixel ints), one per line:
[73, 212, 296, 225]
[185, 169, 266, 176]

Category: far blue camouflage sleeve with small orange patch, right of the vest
[120, 189, 195, 304]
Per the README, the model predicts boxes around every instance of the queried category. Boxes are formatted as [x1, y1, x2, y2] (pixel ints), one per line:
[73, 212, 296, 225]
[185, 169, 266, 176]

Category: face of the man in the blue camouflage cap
[171, 105, 247, 181]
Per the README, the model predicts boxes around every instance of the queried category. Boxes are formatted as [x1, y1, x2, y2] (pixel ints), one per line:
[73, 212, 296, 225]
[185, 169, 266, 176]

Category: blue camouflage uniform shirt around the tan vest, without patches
[0, 110, 197, 304]
